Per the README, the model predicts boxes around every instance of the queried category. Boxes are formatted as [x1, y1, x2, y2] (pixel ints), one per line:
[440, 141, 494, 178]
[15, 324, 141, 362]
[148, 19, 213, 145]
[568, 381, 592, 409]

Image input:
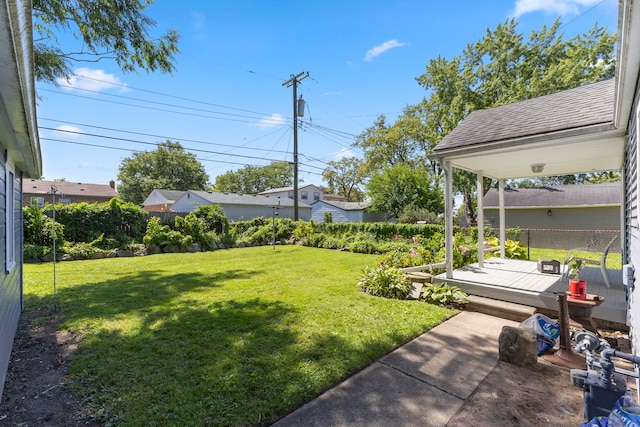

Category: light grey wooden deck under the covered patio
[433, 258, 627, 324]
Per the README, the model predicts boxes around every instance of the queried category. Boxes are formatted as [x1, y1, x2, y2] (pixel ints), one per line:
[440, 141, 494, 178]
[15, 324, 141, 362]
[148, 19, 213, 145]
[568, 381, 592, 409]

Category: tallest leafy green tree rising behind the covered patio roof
[354, 19, 615, 224]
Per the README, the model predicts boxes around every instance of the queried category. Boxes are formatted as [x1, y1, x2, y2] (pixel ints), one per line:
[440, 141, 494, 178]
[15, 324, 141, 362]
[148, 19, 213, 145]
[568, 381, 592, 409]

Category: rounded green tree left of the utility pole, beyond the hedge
[118, 140, 209, 205]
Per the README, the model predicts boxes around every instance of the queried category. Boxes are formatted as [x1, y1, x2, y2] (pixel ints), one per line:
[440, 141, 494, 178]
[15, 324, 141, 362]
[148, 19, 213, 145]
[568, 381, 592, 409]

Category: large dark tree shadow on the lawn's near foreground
[70, 299, 380, 425]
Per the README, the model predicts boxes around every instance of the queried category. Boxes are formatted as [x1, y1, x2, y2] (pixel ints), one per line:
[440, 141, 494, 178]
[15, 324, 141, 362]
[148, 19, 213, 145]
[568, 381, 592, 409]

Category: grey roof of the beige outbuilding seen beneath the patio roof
[484, 182, 620, 208]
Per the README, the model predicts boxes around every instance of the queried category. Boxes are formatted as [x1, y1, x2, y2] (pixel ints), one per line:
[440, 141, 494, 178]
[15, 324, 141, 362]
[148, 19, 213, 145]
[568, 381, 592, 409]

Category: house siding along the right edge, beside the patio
[622, 83, 640, 354]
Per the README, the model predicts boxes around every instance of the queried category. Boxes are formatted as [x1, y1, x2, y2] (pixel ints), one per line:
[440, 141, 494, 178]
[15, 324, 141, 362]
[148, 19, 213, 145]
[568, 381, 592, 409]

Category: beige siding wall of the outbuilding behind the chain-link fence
[484, 206, 620, 230]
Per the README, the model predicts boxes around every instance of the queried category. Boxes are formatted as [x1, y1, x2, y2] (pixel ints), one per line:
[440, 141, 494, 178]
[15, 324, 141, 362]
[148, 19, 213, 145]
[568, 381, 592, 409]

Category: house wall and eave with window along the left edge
[0, 1, 42, 399]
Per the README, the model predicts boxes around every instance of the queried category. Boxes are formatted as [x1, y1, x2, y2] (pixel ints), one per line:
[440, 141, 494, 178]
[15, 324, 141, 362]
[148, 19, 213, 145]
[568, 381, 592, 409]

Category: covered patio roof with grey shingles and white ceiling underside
[432, 79, 626, 179]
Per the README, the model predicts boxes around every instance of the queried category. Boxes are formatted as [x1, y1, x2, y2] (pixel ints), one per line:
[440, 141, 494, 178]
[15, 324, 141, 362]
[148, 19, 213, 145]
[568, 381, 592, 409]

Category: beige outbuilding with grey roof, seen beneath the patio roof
[484, 182, 621, 230]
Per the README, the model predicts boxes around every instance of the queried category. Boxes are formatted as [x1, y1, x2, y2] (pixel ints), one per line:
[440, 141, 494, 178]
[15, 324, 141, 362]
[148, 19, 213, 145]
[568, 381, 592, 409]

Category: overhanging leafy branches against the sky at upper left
[32, 0, 179, 83]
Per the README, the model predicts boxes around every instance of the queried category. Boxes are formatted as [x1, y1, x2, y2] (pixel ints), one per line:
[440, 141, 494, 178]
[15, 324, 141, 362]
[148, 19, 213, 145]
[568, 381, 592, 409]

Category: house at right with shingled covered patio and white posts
[430, 0, 640, 366]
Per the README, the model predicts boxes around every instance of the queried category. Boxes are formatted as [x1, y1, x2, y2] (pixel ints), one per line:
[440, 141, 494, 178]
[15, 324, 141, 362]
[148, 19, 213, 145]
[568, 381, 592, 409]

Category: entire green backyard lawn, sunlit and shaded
[25, 246, 454, 425]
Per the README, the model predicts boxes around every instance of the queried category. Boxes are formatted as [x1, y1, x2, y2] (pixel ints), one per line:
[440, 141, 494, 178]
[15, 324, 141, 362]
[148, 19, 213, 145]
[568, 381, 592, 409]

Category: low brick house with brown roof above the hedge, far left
[22, 179, 118, 207]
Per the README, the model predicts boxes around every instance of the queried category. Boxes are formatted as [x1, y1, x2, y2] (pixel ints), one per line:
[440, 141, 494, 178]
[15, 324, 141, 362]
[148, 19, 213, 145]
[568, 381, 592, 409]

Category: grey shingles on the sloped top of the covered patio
[434, 79, 615, 155]
